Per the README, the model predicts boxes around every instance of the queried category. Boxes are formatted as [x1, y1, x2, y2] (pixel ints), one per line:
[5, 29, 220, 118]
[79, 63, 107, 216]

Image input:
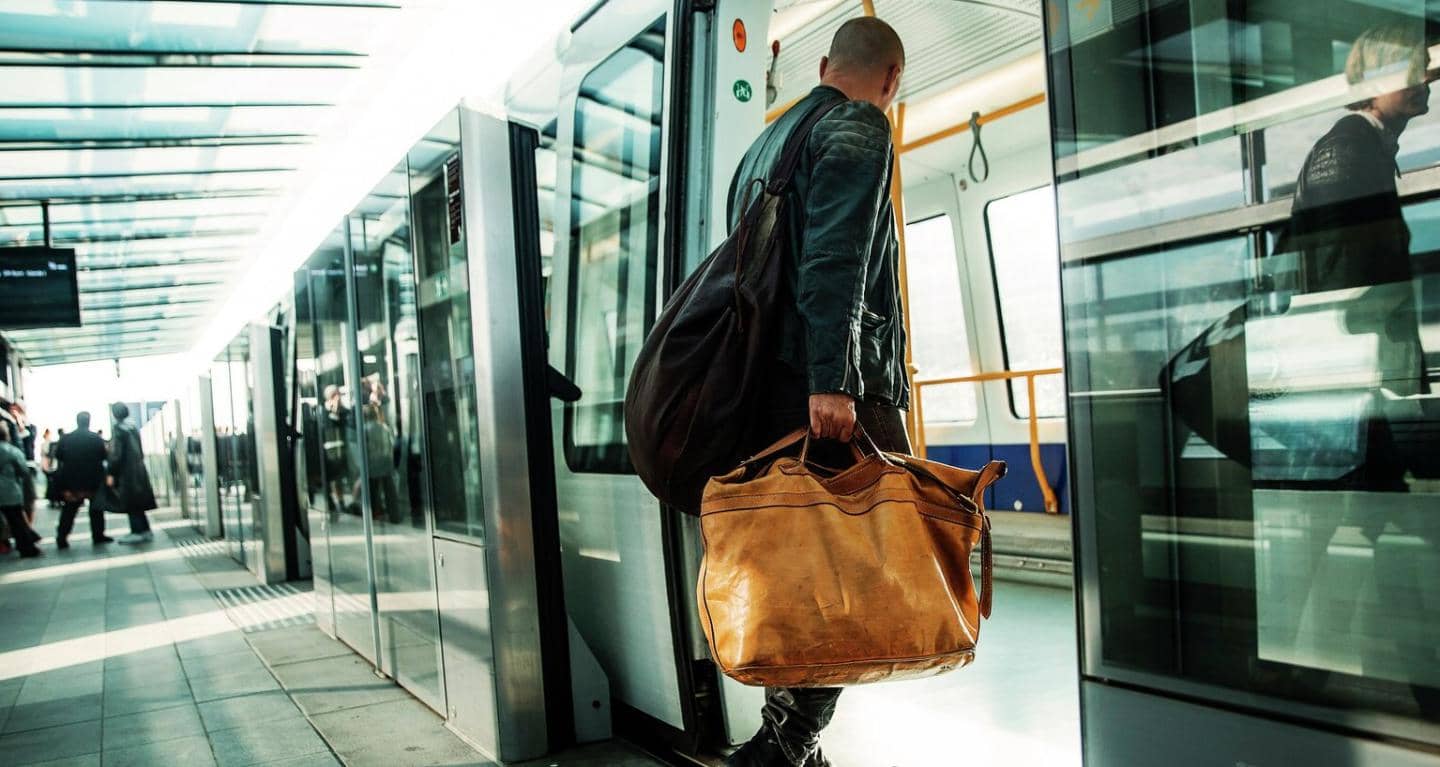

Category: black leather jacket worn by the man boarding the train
[729, 85, 910, 407]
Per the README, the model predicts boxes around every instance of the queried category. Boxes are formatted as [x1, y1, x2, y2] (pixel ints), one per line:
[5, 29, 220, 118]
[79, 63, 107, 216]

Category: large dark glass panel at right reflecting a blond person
[1051, 1, 1440, 744]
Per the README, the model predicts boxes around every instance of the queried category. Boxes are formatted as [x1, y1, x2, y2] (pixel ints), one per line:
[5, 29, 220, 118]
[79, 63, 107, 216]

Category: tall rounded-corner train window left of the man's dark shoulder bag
[564, 20, 665, 473]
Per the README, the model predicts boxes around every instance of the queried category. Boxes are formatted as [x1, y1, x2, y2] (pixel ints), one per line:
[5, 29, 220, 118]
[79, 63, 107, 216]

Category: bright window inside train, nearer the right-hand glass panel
[985, 186, 1066, 419]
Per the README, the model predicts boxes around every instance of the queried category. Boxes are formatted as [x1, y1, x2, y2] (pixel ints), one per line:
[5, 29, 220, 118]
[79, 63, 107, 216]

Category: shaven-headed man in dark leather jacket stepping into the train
[726, 17, 910, 767]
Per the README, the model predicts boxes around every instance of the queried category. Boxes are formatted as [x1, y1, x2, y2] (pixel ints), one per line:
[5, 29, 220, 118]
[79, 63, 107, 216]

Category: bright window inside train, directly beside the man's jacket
[904, 214, 979, 423]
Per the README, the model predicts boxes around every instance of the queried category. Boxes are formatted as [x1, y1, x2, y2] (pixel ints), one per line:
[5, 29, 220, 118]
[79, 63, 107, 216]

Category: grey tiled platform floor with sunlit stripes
[0, 509, 658, 767]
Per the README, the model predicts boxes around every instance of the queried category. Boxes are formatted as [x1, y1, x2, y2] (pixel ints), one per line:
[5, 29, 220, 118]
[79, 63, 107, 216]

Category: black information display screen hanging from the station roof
[0, 248, 81, 330]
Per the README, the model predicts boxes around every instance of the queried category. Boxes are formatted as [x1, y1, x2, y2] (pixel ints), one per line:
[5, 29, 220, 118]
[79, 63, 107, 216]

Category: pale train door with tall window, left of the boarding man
[549, 0, 708, 734]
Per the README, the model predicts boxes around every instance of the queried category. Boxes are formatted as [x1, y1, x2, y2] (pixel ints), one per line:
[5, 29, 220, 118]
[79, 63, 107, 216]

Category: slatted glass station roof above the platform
[0, 0, 413, 366]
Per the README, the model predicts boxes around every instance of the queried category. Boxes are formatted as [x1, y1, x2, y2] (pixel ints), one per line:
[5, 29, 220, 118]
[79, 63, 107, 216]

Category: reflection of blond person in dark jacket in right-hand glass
[1278, 24, 1431, 491]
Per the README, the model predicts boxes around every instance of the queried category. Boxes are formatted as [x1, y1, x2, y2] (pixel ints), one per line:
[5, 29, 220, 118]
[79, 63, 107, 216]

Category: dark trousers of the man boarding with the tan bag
[756, 403, 910, 764]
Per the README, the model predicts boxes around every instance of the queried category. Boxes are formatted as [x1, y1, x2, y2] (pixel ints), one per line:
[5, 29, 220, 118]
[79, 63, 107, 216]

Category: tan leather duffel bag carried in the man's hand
[697, 429, 1005, 686]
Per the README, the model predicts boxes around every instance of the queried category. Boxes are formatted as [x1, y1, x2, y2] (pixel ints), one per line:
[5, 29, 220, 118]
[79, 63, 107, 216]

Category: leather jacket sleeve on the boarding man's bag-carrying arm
[795, 101, 891, 399]
